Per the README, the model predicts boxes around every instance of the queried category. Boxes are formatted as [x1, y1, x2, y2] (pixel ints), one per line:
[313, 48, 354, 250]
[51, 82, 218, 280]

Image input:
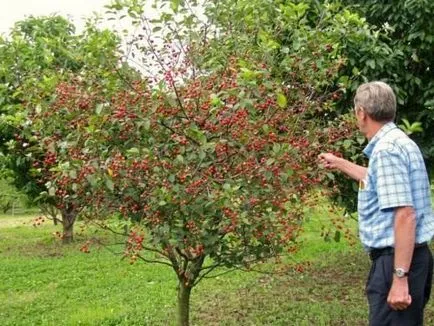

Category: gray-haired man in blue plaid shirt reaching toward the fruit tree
[319, 81, 434, 326]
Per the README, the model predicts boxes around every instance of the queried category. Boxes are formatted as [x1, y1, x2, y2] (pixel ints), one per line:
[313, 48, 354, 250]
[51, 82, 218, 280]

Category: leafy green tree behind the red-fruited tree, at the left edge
[0, 16, 138, 242]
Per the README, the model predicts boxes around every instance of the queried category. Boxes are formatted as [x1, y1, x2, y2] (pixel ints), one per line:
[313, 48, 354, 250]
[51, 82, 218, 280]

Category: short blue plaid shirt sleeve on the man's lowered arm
[374, 148, 413, 210]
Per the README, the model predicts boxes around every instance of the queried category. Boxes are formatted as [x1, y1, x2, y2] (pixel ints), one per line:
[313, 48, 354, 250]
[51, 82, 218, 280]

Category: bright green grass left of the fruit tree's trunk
[0, 217, 176, 325]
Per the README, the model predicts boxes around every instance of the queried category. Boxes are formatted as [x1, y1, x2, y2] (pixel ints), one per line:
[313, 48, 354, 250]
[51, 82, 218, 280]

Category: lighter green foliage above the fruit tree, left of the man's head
[196, 0, 372, 212]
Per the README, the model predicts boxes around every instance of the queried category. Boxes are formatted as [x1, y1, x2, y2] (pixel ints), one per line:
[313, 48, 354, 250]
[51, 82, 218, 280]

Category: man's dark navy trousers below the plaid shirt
[366, 246, 433, 326]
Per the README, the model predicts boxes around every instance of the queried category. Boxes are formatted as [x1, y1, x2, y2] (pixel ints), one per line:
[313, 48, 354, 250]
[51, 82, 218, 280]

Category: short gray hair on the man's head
[354, 81, 396, 122]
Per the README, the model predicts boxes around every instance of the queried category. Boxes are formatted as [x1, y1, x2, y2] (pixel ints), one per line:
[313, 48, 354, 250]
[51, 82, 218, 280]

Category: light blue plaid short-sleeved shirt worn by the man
[358, 122, 434, 250]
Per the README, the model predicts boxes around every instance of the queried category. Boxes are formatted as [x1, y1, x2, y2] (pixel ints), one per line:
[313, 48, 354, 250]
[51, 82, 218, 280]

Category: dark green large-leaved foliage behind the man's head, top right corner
[342, 0, 434, 169]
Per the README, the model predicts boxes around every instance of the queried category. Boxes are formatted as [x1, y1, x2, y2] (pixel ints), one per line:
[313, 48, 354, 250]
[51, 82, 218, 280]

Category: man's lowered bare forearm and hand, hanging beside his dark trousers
[387, 206, 416, 310]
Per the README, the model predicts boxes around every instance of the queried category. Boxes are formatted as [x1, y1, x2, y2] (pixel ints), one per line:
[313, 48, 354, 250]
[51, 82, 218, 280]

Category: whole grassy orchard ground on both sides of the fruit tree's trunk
[0, 204, 434, 326]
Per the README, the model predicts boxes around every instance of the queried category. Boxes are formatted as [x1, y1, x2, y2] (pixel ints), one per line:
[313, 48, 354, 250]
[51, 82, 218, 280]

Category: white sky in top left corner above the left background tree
[0, 0, 111, 35]
